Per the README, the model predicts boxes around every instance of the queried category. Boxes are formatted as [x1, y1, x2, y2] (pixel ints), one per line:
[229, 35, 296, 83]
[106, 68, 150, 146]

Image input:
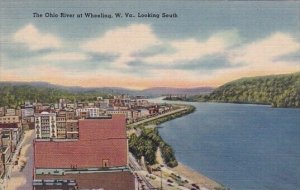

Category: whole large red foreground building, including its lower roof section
[33, 115, 135, 190]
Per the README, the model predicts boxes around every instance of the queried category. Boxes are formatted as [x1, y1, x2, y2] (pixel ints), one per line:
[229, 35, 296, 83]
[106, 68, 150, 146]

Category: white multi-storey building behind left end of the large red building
[34, 112, 57, 139]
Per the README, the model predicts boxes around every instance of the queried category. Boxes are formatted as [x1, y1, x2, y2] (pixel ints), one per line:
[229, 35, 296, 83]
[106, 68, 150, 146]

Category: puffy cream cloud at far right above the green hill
[229, 32, 300, 66]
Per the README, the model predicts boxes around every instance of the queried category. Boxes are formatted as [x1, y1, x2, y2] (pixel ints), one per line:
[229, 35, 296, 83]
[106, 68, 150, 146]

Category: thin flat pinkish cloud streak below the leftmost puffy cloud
[40, 53, 89, 62]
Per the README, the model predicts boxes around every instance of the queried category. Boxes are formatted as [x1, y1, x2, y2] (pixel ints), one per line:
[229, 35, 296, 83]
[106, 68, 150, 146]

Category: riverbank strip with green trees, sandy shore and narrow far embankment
[127, 104, 227, 190]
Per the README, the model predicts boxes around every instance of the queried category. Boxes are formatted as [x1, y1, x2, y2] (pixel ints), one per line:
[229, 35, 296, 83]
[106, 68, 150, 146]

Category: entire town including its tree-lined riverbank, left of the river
[0, 94, 219, 190]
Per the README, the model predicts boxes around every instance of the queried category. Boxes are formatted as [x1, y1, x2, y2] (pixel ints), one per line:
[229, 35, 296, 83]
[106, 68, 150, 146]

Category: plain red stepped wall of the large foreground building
[34, 114, 127, 168]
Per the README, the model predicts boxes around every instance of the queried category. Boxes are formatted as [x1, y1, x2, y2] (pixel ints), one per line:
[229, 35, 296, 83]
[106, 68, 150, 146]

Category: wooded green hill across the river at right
[193, 72, 300, 108]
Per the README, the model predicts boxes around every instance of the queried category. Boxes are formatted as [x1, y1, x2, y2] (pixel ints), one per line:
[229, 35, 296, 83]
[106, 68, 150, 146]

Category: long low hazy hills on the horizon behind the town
[0, 82, 212, 107]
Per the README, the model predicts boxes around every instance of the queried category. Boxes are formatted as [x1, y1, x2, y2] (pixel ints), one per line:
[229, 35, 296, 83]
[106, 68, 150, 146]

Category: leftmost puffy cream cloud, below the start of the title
[13, 24, 61, 51]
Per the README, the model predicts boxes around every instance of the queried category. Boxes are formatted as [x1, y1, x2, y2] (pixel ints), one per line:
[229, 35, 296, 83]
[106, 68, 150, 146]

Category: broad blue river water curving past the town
[151, 100, 300, 190]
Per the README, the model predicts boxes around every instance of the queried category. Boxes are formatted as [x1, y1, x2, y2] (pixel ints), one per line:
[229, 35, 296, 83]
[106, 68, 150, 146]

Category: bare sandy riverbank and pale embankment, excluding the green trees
[128, 105, 224, 190]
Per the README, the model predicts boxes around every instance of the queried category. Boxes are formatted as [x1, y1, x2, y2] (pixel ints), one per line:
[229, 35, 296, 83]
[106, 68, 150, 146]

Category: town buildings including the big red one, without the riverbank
[0, 95, 176, 190]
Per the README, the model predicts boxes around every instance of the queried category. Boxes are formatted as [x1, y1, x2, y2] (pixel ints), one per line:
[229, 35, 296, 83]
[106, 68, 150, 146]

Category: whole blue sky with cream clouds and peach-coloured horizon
[0, 0, 300, 88]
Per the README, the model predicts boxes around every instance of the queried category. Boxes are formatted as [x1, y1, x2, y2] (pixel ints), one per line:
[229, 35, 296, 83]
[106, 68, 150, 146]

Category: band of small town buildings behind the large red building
[0, 95, 172, 139]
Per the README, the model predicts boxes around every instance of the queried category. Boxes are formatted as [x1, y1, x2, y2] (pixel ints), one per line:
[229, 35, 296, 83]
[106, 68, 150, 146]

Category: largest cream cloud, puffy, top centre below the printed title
[82, 24, 161, 66]
